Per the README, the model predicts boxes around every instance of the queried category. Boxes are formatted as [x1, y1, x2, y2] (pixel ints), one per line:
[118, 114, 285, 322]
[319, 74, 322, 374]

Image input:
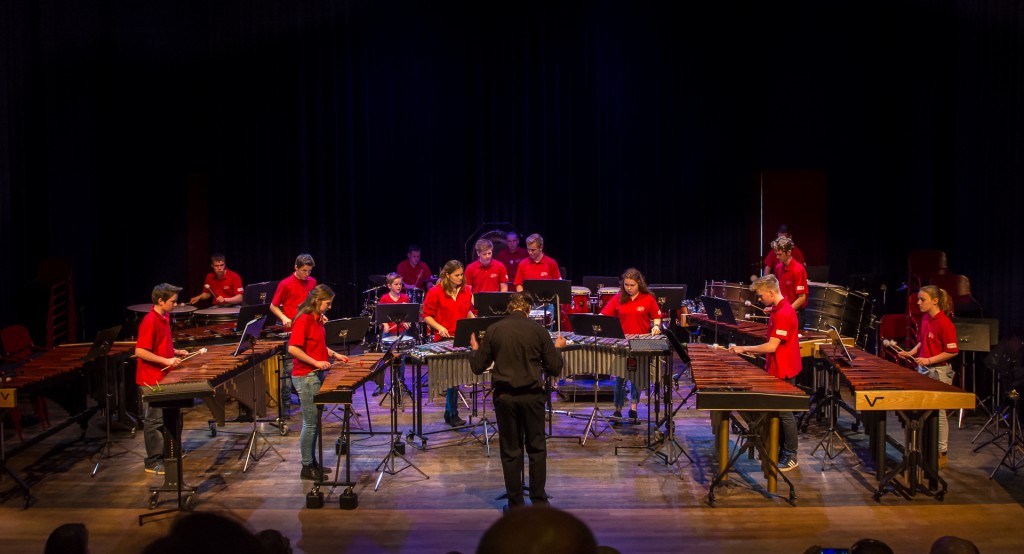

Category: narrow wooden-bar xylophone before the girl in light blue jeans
[309, 352, 394, 507]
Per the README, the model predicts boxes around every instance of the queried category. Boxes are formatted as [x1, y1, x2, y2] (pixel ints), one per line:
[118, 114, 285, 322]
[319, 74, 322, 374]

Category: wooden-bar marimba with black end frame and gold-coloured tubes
[687, 343, 808, 506]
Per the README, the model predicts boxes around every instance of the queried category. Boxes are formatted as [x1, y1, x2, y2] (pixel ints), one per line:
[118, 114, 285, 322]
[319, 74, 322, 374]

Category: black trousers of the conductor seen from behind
[495, 391, 548, 506]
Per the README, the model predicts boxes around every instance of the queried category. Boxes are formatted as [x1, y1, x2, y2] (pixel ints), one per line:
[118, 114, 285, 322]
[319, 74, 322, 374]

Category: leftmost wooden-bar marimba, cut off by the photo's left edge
[0, 343, 134, 508]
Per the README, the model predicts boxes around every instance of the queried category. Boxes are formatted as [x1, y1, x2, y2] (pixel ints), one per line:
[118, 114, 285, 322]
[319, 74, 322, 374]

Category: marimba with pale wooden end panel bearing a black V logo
[818, 345, 976, 501]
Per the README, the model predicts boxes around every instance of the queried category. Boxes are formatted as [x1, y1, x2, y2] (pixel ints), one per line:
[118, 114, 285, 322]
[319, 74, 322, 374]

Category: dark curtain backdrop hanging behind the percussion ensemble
[0, 0, 1024, 342]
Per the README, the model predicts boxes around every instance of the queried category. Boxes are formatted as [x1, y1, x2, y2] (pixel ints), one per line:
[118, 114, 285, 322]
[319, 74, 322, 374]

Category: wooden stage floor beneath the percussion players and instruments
[0, 360, 1024, 553]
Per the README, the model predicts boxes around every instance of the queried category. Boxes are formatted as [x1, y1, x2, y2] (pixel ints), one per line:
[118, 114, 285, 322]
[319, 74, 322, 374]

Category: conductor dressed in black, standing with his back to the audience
[470, 293, 565, 508]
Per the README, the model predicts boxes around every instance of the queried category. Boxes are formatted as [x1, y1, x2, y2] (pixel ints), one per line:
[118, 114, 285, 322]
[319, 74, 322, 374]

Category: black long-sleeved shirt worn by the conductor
[469, 311, 562, 390]
